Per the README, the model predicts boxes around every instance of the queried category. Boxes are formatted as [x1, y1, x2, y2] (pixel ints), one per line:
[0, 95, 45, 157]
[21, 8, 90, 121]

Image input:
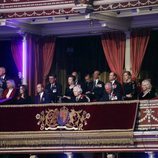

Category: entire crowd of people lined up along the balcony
[0, 67, 156, 104]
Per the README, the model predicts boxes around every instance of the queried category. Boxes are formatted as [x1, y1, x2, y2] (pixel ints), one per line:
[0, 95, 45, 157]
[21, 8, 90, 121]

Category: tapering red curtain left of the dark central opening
[42, 37, 55, 85]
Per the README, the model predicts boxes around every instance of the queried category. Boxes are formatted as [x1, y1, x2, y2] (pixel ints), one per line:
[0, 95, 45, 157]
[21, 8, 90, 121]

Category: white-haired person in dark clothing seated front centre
[73, 85, 90, 103]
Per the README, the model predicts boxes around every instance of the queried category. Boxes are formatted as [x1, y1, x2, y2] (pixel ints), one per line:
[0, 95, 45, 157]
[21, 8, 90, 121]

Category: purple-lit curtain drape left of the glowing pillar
[11, 39, 22, 73]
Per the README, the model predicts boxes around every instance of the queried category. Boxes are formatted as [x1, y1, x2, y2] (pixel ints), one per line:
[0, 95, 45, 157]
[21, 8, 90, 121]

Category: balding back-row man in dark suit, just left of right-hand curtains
[92, 70, 104, 101]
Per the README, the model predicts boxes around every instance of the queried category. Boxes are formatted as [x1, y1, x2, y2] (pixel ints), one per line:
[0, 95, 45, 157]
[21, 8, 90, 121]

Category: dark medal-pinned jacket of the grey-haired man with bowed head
[100, 91, 122, 101]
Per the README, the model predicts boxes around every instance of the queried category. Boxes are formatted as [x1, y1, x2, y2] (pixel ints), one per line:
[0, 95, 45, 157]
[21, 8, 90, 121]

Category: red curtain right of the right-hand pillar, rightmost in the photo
[130, 29, 150, 79]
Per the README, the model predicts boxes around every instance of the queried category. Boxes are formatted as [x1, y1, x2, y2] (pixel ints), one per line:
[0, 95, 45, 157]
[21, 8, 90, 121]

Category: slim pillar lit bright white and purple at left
[22, 35, 27, 85]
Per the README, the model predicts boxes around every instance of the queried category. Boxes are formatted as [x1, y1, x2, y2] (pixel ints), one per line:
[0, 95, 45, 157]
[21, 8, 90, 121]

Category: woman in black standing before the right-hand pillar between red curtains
[123, 71, 137, 100]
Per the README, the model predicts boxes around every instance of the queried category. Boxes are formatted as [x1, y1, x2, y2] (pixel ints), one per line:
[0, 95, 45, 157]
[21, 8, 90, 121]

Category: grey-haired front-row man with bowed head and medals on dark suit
[100, 82, 122, 101]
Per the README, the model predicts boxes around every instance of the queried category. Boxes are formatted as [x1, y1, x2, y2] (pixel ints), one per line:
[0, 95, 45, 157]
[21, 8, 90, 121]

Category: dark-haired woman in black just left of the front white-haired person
[62, 76, 75, 103]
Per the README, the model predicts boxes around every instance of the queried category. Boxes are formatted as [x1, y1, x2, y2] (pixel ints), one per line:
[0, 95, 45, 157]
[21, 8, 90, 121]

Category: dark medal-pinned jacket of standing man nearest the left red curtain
[45, 83, 62, 103]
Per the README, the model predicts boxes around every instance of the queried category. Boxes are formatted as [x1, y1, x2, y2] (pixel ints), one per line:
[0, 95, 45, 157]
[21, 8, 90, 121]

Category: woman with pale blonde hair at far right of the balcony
[138, 79, 155, 100]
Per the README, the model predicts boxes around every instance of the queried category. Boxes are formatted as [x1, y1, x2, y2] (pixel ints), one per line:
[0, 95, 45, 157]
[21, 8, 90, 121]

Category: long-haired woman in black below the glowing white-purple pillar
[16, 85, 31, 104]
